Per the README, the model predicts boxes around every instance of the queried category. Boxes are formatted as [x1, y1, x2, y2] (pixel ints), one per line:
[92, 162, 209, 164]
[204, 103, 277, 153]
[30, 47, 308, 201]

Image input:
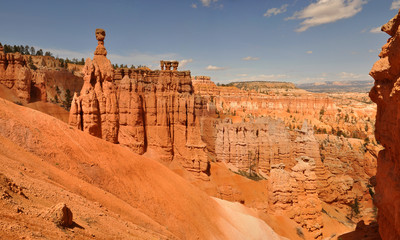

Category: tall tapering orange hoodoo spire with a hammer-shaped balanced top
[70, 29, 119, 143]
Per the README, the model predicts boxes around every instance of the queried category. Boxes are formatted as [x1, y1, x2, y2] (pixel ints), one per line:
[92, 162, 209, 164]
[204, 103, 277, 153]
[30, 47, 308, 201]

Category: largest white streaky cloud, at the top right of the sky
[287, 0, 367, 32]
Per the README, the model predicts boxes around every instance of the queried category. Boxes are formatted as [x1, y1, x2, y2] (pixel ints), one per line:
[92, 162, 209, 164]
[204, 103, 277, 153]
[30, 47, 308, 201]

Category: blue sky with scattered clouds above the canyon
[0, 0, 400, 84]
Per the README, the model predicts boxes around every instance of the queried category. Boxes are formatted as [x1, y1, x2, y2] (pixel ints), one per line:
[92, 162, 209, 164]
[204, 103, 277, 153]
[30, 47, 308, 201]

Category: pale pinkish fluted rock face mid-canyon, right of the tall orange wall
[215, 118, 292, 174]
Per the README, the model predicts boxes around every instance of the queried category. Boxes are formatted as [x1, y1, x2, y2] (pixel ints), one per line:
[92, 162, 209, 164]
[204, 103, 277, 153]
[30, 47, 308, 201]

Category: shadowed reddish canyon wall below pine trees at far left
[0, 43, 83, 107]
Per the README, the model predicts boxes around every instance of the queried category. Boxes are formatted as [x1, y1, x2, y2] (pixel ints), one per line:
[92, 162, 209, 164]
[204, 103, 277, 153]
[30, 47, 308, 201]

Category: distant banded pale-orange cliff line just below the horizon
[193, 76, 336, 119]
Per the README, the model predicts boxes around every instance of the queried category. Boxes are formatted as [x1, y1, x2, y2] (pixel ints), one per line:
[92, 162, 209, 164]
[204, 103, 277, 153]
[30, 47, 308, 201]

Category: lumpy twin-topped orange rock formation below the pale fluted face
[268, 157, 323, 239]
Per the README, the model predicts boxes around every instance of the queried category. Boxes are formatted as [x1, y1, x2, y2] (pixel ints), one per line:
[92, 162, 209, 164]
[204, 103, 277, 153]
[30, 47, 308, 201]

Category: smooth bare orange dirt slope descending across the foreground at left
[0, 99, 280, 239]
